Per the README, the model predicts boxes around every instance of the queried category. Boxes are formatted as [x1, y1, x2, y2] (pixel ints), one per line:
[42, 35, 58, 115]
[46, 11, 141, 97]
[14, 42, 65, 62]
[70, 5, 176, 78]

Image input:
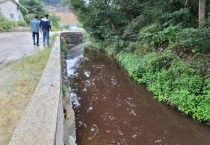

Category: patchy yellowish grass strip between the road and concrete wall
[0, 35, 56, 145]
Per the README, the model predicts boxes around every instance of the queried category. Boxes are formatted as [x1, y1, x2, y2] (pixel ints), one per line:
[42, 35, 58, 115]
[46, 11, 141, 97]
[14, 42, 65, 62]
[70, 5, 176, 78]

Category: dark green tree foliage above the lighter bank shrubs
[68, 0, 210, 50]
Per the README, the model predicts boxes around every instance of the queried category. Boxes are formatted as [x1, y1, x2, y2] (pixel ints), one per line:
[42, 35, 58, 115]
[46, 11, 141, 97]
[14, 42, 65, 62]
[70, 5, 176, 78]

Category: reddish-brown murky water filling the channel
[67, 48, 210, 145]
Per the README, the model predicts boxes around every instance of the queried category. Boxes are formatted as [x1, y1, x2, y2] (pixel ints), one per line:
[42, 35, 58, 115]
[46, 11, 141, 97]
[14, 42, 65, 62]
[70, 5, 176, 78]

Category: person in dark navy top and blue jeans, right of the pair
[39, 14, 51, 46]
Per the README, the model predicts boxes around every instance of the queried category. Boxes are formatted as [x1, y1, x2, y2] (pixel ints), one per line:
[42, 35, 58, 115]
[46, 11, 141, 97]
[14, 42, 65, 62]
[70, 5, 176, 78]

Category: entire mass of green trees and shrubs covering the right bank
[68, 0, 210, 123]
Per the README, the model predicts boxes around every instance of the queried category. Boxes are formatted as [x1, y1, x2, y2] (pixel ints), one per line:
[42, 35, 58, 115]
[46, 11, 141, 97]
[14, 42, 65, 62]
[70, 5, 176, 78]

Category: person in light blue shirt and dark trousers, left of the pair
[30, 16, 39, 46]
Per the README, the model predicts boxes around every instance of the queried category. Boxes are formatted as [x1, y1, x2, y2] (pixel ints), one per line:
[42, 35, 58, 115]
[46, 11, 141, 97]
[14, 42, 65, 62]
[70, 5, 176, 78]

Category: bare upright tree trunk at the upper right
[199, 0, 206, 28]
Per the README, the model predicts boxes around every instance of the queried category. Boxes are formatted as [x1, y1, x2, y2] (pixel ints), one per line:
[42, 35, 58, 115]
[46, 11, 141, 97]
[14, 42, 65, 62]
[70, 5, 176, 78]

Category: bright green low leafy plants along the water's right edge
[117, 51, 210, 122]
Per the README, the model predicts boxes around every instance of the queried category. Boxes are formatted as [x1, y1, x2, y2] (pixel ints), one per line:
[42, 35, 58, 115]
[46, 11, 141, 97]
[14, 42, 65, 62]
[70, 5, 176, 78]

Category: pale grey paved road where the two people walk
[0, 32, 43, 65]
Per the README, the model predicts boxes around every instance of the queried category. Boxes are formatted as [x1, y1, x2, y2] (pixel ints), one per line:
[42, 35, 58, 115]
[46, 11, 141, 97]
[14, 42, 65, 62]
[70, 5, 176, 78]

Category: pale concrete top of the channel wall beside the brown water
[9, 37, 71, 145]
